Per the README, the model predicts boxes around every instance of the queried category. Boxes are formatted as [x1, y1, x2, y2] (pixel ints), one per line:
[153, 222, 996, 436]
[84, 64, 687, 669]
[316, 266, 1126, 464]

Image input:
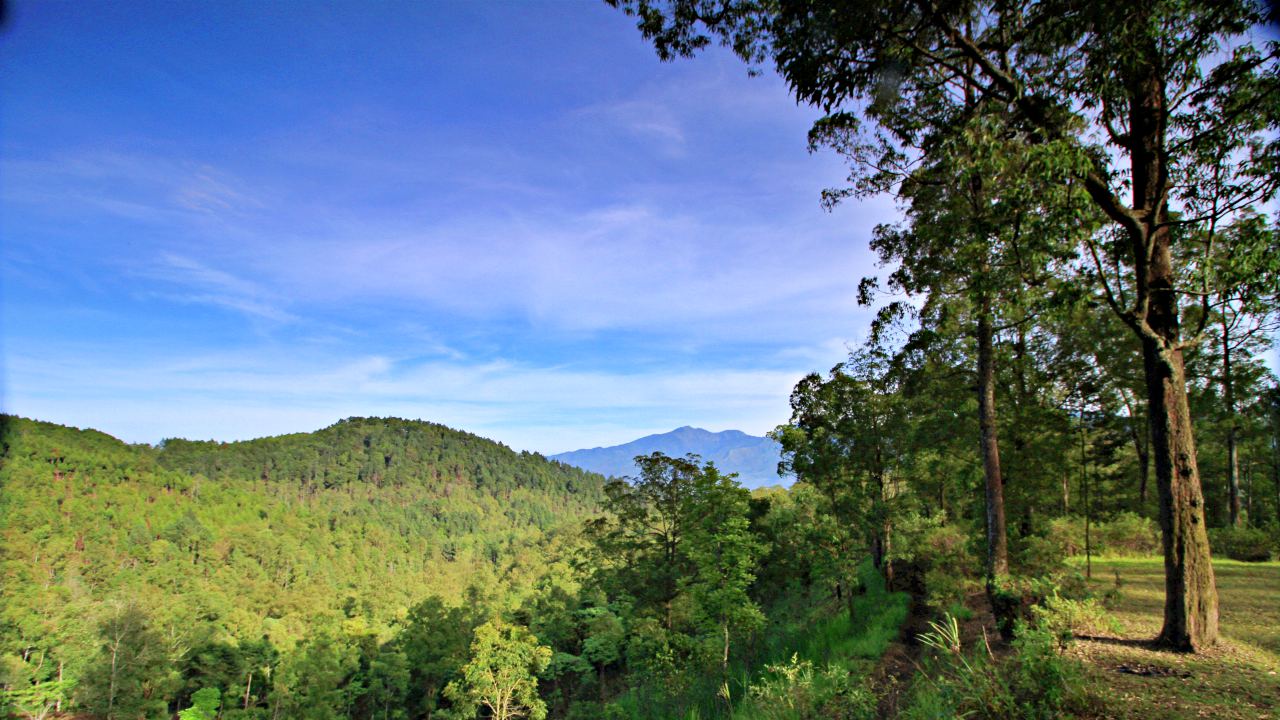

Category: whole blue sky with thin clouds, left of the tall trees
[0, 0, 892, 454]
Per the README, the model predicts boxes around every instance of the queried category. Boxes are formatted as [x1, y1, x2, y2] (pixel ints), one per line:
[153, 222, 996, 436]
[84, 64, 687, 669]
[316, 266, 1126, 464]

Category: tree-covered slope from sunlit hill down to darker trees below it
[0, 416, 906, 720]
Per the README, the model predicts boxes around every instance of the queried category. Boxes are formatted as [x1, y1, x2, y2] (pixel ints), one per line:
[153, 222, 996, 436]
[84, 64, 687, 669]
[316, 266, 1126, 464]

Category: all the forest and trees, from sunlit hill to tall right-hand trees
[0, 0, 1280, 720]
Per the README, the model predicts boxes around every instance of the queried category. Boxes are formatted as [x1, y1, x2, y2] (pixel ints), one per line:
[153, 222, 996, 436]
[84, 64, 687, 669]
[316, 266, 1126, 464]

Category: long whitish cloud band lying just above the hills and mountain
[5, 348, 803, 454]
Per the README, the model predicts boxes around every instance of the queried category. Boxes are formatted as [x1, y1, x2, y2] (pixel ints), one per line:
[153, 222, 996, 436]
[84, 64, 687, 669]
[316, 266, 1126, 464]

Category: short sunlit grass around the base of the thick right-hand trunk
[1071, 557, 1280, 720]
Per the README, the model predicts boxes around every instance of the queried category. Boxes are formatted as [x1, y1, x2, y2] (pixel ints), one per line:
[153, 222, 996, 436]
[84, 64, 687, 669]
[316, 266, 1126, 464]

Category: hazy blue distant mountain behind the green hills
[550, 425, 792, 488]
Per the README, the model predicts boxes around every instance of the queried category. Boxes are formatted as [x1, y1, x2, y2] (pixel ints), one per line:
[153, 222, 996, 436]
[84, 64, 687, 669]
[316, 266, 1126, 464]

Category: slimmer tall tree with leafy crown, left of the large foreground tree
[855, 105, 1089, 585]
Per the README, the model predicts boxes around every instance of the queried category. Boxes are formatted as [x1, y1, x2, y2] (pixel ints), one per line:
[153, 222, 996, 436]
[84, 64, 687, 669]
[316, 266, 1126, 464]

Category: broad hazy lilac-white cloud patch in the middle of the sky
[241, 196, 868, 334]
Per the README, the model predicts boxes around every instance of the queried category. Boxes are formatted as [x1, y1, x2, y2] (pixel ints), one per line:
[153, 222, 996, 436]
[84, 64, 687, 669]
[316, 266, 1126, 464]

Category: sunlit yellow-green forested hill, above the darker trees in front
[0, 415, 603, 650]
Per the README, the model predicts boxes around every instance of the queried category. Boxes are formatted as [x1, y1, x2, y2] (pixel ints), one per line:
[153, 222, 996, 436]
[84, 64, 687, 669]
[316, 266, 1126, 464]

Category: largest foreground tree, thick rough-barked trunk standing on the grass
[611, 0, 1280, 651]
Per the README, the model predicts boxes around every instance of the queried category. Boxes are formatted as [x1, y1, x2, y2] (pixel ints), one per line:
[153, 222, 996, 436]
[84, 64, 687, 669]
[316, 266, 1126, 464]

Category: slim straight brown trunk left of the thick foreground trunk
[978, 296, 1009, 576]
